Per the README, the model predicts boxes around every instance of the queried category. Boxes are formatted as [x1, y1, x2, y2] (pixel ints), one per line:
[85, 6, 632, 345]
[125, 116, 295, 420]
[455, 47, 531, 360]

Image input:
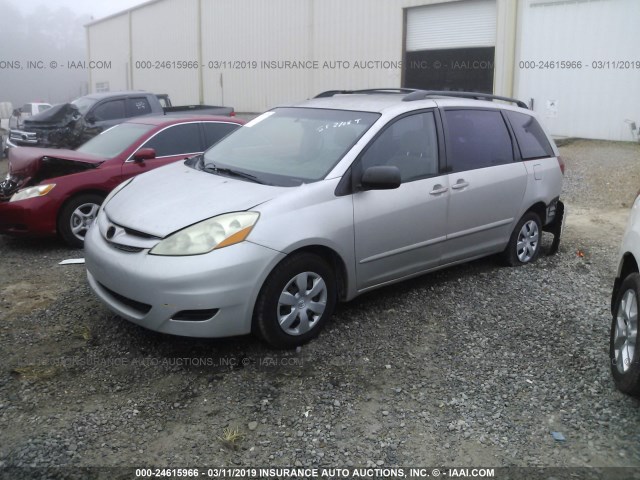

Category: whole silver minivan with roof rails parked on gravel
[85, 89, 564, 347]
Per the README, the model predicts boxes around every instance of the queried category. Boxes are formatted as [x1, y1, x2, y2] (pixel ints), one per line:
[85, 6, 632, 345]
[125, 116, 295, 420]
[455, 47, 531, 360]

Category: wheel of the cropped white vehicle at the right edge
[609, 273, 640, 397]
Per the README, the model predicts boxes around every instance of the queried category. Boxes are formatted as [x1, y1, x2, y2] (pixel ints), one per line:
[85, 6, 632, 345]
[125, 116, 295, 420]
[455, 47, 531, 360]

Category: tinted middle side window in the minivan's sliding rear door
[444, 110, 513, 172]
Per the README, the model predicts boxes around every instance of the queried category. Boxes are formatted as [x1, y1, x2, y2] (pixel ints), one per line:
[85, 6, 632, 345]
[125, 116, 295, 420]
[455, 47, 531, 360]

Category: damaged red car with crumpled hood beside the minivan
[0, 116, 244, 247]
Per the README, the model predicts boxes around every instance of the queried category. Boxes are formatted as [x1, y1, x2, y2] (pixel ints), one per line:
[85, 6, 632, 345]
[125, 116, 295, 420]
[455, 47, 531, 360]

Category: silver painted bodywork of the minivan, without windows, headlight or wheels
[85, 94, 562, 337]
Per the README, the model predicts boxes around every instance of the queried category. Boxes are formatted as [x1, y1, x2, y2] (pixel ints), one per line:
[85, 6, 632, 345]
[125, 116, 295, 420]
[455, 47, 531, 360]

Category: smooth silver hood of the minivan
[104, 163, 287, 238]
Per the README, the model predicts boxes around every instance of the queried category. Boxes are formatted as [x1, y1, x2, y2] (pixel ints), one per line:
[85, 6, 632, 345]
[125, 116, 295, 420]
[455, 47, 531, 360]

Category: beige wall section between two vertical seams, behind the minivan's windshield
[202, 0, 313, 112]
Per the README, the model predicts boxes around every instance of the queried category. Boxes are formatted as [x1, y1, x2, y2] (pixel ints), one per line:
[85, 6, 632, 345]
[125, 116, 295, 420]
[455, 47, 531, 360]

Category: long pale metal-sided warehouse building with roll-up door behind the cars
[87, 0, 640, 141]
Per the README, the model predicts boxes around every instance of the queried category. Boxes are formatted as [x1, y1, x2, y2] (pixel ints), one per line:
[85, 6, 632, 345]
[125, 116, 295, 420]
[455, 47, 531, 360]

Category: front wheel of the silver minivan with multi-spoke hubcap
[254, 253, 337, 348]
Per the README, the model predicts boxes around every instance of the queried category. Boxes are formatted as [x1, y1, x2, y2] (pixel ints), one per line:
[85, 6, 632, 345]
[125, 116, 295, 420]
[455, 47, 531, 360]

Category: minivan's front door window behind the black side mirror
[361, 112, 438, 183]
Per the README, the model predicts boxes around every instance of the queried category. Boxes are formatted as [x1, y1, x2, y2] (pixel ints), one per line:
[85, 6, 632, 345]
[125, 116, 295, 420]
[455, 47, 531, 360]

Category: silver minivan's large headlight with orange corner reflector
[149, 212, 260, 256]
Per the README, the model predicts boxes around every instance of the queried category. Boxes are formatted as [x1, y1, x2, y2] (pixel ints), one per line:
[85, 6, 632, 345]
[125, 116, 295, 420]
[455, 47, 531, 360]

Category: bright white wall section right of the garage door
[515, 0, 640, 140]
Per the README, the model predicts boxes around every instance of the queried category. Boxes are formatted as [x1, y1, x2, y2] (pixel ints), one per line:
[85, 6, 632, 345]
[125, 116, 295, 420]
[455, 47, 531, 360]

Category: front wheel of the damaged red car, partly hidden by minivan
[58, 193, 104, 248]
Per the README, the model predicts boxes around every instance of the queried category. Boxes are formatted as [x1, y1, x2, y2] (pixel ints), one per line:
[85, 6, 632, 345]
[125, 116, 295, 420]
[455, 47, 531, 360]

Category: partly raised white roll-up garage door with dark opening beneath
[403, 0, 497, 93]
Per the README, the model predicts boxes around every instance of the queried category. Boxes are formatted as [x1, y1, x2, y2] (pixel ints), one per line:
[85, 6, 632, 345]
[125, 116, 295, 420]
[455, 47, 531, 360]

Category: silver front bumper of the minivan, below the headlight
[85, 227, 284, 337]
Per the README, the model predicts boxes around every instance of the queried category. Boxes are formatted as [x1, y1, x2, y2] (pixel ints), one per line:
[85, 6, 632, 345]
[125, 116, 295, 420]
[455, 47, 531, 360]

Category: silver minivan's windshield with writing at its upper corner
[201, 108, 380, 186]
